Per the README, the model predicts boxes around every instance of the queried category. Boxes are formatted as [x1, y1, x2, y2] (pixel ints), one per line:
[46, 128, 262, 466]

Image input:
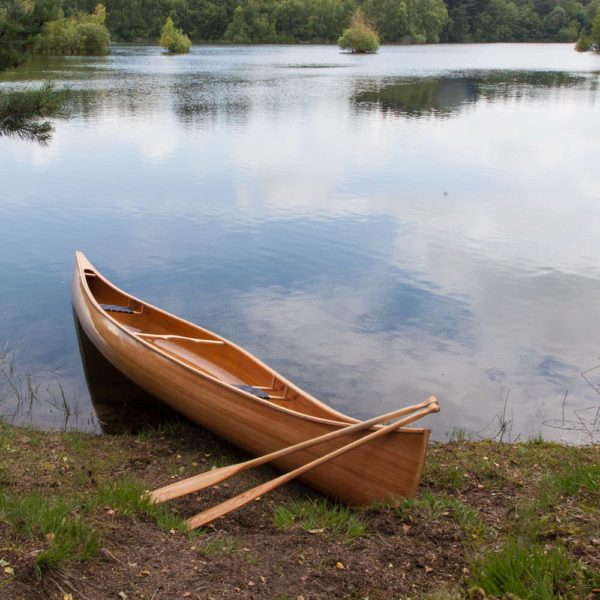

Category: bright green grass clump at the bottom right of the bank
[470, 541, 582, 600]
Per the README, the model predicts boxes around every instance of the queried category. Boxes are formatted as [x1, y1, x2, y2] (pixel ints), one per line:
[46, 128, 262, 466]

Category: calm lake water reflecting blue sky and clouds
[0, 44, 600, 442]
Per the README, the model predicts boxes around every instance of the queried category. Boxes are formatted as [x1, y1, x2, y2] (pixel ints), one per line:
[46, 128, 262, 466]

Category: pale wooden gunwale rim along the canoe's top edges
[75, 251, 429, 435]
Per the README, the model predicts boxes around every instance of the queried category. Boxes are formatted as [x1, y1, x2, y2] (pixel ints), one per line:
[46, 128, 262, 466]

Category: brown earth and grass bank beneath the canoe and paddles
[0, 424, 600, 600]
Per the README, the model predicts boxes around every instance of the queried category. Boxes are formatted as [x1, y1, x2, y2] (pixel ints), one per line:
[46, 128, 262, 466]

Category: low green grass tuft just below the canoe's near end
[273, 499, 367, 539]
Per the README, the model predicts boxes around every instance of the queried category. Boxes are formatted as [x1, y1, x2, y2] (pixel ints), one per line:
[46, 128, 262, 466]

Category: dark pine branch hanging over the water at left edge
[0, 83, 68, 144]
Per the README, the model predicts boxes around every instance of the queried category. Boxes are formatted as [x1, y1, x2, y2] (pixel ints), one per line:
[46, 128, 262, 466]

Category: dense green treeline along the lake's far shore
[36, 0, 600, 43]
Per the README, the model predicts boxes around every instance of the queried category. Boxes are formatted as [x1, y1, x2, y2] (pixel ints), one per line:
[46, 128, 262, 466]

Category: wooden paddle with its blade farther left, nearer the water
[150, 396, 437, 504]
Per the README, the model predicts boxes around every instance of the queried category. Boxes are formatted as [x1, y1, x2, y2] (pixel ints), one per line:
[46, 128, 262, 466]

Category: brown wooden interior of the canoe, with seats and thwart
[84, 268, 351, 421]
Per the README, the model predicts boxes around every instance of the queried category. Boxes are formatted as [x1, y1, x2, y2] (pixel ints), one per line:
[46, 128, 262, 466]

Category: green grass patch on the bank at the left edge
[0, 494, 99, 576]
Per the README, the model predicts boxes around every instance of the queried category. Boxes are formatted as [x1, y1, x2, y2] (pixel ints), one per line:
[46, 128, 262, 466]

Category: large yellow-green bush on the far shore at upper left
[35, 4, 110, 55]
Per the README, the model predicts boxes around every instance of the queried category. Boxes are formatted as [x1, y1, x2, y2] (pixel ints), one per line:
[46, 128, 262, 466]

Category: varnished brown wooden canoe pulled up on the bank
[72, 252, 429, 505]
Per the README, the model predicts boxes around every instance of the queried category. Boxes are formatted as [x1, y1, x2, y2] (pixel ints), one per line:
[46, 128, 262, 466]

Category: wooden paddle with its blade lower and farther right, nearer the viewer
[186, 402, 440, 529]
